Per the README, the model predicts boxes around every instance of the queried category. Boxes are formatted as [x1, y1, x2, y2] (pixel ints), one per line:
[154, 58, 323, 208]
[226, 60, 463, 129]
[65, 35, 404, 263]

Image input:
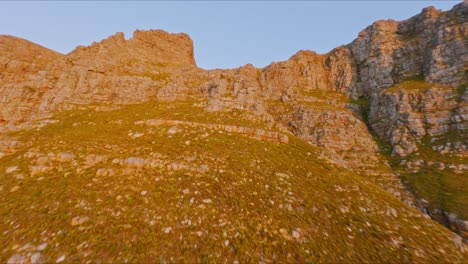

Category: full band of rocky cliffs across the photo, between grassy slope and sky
[0, 1, 468, 241]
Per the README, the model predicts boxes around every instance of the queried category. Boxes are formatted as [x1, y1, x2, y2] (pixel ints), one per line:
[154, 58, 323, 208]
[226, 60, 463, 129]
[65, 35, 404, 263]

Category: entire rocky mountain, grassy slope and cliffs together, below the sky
[0, 1, 468, 263]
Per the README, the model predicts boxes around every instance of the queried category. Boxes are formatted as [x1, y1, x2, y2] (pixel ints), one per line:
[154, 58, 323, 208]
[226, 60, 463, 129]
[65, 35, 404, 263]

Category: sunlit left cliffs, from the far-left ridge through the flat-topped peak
[0, 30, 196, 129]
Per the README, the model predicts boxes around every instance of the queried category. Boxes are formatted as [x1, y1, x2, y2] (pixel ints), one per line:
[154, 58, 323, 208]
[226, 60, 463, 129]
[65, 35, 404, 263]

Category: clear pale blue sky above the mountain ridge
[0, 1, 461, 69]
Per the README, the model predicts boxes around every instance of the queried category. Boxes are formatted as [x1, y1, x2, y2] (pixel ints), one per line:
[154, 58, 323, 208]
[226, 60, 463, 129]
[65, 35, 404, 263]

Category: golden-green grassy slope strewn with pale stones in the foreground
[0, 102, 463, 263]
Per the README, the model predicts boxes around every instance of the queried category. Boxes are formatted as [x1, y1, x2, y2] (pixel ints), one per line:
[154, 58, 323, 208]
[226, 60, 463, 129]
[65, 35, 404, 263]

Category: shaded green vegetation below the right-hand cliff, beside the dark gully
[377, 131, 468, 219]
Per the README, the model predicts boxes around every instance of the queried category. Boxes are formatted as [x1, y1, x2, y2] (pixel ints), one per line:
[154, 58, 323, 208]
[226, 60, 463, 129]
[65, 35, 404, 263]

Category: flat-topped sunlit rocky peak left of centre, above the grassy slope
[50, 30, 196, 109]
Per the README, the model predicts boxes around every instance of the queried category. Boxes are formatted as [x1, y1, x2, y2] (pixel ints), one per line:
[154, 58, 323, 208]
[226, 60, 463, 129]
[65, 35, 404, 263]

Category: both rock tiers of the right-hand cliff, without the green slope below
[351, 3, 467, 159]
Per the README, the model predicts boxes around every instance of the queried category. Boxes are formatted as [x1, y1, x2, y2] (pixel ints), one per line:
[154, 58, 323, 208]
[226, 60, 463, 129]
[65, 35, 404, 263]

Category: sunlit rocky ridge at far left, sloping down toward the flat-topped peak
[0, 36, 63, 126]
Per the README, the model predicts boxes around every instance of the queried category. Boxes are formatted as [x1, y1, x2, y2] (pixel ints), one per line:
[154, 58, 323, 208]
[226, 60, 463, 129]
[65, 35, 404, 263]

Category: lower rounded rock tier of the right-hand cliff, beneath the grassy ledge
[371, 82, 467, 157]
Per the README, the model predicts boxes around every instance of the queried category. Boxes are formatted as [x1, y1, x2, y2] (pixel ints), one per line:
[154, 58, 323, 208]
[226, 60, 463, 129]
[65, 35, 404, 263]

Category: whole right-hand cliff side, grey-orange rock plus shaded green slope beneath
[347, 1, 468, 239]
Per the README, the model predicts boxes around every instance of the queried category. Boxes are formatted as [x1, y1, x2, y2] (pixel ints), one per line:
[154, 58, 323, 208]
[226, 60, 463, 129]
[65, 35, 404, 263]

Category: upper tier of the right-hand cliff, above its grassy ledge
[348, 2, 468, 95]
